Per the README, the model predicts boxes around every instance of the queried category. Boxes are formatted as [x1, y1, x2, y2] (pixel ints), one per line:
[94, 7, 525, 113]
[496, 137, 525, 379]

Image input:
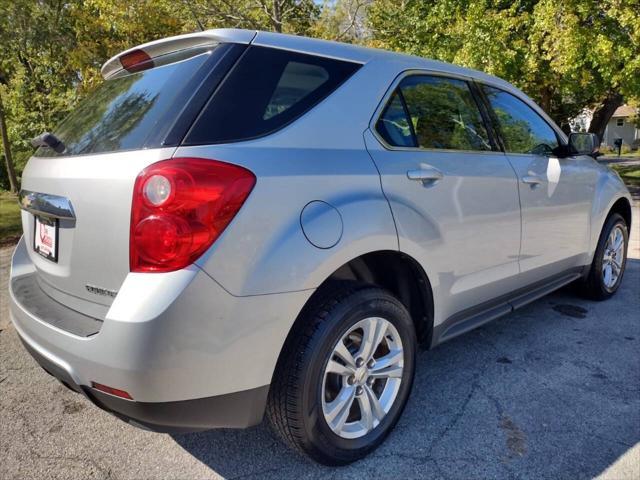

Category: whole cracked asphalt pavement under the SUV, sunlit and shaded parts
[0, 205, 640, 479]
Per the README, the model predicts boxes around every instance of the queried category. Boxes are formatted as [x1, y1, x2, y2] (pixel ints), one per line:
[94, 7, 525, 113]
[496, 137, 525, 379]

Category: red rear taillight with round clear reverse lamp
[129, 158, 256, 272]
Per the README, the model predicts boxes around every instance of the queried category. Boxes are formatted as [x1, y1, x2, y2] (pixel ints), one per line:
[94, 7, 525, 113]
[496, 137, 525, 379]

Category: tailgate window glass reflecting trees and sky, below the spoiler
[36, 48, 218, 157]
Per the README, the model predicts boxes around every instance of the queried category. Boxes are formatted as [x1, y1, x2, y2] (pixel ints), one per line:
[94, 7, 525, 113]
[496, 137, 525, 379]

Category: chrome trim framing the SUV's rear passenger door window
[369, 68, 504, 155]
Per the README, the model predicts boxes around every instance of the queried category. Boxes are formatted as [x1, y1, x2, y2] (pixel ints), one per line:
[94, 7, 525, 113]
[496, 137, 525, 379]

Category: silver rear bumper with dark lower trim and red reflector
[9, 236, 312, 431]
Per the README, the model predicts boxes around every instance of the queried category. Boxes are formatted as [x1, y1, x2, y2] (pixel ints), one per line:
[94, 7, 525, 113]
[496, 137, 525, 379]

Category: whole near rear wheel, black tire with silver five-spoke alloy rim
[267, 284, 416, 465]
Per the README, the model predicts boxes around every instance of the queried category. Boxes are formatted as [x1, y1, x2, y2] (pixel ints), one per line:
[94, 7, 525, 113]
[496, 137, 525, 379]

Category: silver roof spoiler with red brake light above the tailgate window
[100, 28, 257, 80]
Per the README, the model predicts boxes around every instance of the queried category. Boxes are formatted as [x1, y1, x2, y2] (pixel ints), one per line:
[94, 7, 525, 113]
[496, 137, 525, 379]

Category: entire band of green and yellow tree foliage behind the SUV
[0, 0, 640, 187]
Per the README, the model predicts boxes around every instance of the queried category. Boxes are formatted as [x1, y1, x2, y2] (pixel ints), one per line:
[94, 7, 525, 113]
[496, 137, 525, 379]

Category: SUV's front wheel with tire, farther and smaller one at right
[579, 213, 629, 300]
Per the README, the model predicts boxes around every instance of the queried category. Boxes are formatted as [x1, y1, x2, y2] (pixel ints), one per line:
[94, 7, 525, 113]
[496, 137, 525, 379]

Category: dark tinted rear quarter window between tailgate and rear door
[184, 47, 360, 145]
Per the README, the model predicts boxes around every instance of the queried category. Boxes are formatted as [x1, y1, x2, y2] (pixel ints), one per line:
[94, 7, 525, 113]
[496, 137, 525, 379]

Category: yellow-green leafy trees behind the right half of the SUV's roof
[369, 0, 640, 138]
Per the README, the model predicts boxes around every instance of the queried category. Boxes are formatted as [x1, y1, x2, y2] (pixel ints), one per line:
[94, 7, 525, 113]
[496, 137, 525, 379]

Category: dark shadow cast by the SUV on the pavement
[173, 259, 640, 478]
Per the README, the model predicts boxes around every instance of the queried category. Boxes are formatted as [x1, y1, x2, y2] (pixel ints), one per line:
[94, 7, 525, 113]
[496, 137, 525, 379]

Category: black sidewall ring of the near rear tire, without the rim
[302, 288, 416, 463]
